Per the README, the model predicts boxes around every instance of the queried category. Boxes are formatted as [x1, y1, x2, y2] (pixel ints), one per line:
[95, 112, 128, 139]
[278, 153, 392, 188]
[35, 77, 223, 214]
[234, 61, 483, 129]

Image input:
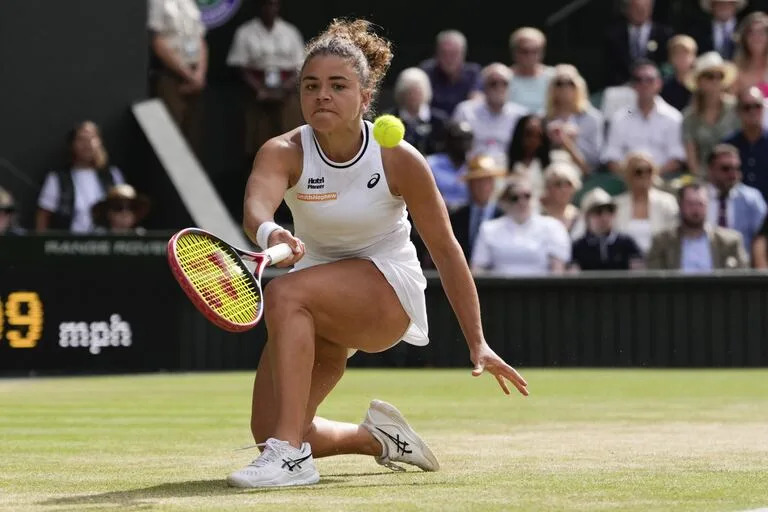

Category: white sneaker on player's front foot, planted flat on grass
[227, 437, 320, 488]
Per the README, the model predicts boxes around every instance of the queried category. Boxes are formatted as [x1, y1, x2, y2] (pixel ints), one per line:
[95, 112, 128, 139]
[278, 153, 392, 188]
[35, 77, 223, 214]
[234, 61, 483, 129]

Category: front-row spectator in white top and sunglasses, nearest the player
[472, 178, 571, 276]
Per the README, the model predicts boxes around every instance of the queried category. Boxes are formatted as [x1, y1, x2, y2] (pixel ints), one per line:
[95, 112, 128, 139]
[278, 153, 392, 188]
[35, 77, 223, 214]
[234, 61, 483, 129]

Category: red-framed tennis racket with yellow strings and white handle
[168, 228, 293, 332]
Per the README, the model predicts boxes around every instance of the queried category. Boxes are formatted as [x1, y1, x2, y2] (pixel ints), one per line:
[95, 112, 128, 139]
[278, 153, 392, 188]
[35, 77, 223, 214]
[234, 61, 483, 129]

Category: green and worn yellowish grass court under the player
[0, 369, 768, 512]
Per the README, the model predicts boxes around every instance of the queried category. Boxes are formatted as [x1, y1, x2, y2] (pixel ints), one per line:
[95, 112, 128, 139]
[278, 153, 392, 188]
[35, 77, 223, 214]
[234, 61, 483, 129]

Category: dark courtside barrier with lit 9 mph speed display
[0, 234, 768, 374]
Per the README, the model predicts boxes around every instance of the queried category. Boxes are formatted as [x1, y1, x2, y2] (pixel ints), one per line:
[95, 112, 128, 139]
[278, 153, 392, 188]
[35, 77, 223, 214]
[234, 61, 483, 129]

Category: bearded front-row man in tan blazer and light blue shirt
[646, 183, 747, 272]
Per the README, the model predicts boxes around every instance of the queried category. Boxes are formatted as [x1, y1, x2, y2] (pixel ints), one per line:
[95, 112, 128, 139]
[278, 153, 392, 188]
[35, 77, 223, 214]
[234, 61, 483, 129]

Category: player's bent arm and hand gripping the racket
[243, 135, 304, 267]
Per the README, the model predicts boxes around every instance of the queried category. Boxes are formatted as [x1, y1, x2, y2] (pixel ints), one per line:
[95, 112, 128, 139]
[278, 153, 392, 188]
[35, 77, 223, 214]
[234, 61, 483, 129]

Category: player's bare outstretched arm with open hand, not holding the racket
[382, 144, 528, 395]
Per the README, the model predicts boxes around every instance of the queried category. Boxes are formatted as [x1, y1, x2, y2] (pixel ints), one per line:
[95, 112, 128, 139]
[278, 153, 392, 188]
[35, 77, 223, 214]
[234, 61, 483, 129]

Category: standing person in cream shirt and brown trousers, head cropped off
[148, 0, 208, 156]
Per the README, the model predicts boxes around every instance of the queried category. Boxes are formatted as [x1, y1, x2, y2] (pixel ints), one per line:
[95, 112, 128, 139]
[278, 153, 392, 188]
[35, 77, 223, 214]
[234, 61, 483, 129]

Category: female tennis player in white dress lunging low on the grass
[228, 20, 528, 487]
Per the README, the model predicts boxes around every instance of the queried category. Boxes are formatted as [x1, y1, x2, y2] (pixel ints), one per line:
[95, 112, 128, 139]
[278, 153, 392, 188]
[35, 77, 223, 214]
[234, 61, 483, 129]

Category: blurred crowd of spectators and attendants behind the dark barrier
[0, 0, 768, 275]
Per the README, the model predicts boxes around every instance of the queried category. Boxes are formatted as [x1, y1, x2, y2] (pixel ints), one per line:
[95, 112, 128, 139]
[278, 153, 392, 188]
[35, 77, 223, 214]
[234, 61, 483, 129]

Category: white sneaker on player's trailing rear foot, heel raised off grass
[362, 400, 440, 471]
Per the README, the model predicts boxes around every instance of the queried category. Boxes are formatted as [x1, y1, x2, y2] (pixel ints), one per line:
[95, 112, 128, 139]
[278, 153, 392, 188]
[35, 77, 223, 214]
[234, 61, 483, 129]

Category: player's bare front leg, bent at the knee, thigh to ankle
[264, 259, 410, 447]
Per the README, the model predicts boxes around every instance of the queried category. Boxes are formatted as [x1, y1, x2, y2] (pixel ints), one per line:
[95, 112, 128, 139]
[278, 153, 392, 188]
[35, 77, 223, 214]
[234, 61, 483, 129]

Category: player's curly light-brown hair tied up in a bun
[302, 19, 392, 110]
